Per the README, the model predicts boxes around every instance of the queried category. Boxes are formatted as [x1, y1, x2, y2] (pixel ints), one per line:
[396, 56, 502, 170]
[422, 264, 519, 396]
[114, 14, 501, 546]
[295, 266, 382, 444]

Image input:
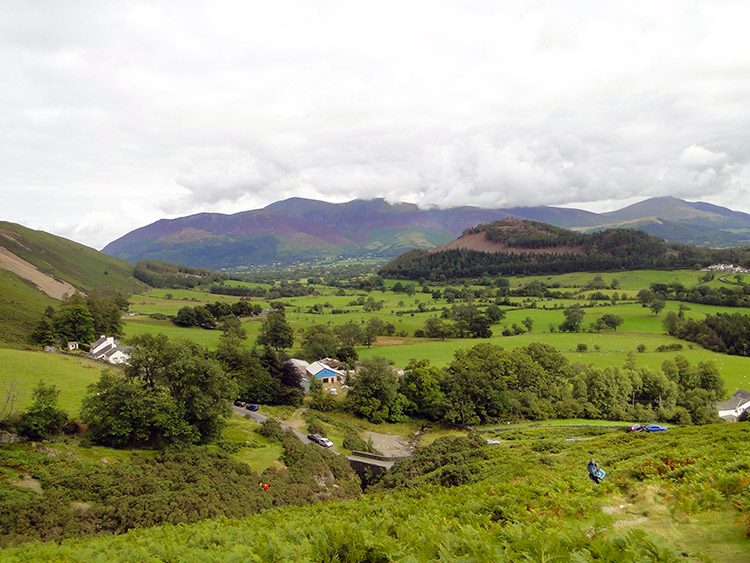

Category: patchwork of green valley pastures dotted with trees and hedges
[114, 270, 750, 393]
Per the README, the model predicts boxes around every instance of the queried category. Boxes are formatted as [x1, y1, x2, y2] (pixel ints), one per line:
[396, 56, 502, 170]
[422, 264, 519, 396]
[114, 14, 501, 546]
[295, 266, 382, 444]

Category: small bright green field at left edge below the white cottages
[0, 348, 117, 417]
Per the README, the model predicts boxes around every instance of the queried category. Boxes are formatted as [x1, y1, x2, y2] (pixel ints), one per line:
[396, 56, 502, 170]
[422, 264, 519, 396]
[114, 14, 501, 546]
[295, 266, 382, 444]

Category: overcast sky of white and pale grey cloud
[0, 0, 750, 248]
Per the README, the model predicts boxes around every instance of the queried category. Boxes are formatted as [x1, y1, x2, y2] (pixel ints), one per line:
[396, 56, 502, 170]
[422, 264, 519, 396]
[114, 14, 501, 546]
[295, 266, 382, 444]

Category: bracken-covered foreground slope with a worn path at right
[3, 424, 750, 563]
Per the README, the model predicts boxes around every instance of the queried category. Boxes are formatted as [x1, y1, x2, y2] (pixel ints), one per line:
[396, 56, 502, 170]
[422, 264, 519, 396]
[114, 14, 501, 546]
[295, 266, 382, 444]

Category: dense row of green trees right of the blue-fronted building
[334, 343, 724, 427]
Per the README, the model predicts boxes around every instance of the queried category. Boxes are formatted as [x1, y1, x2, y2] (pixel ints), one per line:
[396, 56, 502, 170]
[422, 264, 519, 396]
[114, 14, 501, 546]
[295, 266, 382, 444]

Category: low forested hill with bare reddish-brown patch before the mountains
[380, 219, 750, 280]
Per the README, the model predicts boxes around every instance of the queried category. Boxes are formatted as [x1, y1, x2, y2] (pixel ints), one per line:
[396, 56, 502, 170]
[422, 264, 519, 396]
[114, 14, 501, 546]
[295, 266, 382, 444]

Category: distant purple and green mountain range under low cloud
[103, 197, 750, 269]
